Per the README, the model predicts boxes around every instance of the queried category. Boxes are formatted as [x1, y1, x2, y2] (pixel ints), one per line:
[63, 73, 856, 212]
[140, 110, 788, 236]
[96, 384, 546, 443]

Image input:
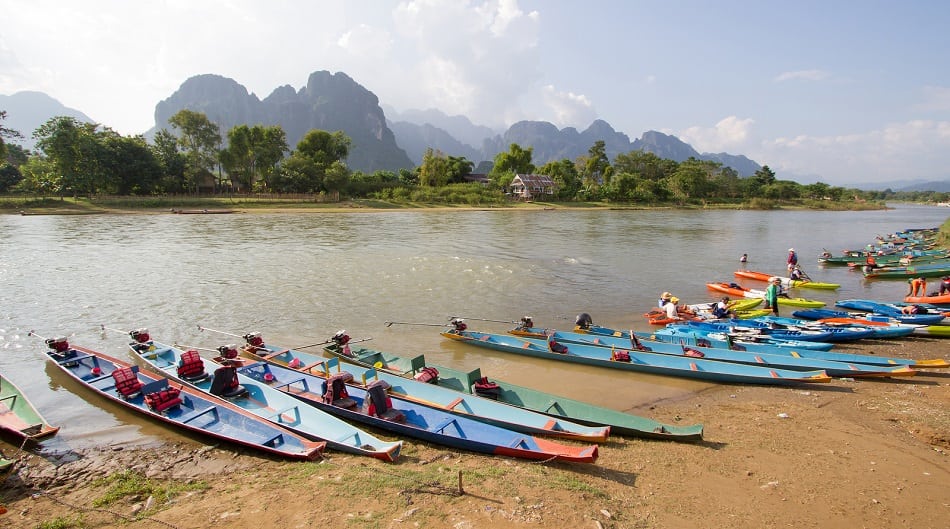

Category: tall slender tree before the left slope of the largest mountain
[168, 109, 221, 191]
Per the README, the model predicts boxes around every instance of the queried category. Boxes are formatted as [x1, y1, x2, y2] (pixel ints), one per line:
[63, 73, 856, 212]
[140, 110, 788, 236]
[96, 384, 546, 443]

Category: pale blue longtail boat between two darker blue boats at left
[129, 329, 402, 462]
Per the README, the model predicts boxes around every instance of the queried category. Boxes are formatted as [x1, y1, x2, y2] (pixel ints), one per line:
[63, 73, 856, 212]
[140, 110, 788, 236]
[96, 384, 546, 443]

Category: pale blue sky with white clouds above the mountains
[0, 0, 950, 186]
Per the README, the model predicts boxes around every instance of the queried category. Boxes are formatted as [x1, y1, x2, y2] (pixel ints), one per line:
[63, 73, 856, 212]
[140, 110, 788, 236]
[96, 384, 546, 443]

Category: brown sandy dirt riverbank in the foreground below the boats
[0, 338, 950, 529]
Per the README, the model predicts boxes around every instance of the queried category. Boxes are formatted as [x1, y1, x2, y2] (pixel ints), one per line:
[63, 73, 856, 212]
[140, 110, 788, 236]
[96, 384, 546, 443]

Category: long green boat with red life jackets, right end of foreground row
[324, 344, 703, 441]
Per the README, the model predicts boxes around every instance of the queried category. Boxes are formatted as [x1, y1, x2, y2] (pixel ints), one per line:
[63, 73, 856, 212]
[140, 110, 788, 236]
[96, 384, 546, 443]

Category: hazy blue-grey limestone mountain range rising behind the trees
[0, 71, 772, 176]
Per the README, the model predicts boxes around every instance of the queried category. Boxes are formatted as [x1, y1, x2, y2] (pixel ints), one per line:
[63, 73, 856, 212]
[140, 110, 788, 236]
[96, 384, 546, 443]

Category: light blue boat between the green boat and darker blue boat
[238, 333, 610, 443]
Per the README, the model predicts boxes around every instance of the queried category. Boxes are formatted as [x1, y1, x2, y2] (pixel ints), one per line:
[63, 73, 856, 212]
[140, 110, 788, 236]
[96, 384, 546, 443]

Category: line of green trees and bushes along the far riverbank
[0, 110, 950, 204]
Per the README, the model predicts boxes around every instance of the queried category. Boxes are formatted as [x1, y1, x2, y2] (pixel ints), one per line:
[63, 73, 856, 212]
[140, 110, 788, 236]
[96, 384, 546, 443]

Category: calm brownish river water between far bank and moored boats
[0, 206, 947, 450]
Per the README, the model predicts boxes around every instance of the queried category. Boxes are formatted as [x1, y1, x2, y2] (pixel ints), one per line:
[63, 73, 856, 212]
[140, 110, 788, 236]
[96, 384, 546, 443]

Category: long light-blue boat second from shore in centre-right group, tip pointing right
[509, 329, 914, 377]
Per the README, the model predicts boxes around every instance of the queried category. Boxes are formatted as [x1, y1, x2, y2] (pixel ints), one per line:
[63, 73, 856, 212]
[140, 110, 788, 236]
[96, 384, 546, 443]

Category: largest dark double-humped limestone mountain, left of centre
[146, 71, 413, 172]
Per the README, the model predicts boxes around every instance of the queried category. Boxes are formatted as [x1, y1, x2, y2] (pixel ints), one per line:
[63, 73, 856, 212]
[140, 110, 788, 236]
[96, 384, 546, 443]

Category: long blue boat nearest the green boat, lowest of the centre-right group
[441, 330, 831, 385]
